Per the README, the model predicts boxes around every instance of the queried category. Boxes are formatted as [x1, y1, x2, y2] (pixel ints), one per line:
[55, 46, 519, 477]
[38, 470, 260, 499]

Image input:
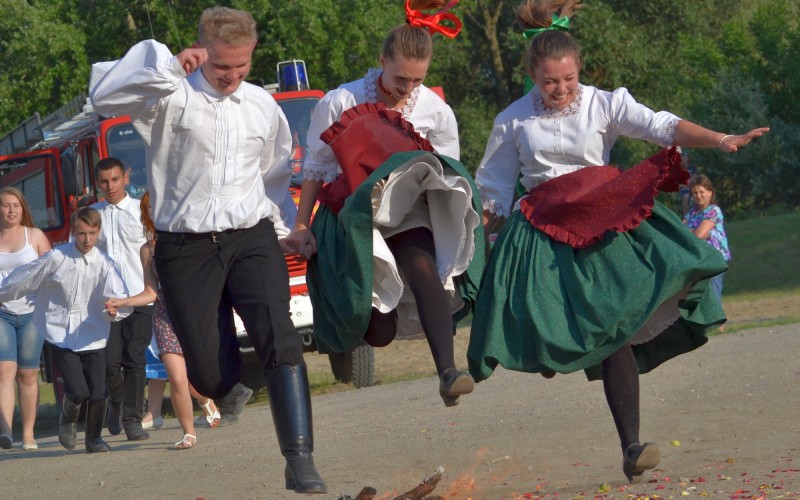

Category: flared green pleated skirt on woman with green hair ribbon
[467, 202, 727, 381]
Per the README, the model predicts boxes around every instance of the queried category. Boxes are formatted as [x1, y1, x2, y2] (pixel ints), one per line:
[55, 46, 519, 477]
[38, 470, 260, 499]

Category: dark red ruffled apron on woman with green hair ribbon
[520, 147, 689, 248]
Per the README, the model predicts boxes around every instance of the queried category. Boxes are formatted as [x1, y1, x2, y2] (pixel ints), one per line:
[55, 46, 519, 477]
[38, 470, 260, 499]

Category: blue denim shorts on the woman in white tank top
[0, 311, 44, 369]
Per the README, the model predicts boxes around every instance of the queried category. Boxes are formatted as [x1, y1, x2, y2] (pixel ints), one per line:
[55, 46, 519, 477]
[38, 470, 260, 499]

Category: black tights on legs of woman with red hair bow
[364, 227, 455, 374]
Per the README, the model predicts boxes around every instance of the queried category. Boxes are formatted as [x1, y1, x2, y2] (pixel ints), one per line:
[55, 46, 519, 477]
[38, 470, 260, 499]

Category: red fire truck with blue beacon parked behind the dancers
[0, 60, 375, 401]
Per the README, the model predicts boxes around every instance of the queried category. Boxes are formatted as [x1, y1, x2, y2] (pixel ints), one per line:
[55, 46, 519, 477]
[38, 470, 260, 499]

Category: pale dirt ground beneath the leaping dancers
[0, 318, 800, 499]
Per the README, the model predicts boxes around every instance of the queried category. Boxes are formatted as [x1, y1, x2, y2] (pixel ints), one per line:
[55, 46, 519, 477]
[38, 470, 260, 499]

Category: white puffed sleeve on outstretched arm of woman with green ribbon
[609, 87, 681, 147]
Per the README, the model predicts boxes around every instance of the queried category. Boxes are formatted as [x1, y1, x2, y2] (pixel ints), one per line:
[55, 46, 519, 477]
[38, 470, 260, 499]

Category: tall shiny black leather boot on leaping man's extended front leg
[266, 365, 328, 494]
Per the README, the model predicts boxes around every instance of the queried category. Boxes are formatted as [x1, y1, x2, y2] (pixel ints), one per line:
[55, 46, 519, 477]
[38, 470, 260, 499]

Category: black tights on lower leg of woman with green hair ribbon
[603, 343, 639, 453]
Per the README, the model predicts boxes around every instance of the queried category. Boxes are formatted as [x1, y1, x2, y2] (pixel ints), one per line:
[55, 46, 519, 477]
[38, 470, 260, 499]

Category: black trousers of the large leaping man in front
[154, 219, 304, 398]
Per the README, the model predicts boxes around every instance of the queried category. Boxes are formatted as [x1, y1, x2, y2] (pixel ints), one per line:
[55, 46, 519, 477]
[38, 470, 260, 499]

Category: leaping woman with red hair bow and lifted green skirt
[288, 0, 483, 406]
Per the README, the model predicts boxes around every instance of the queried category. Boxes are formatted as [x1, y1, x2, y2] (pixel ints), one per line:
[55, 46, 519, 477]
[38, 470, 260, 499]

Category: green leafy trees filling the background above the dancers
[0, 0, 800, 218]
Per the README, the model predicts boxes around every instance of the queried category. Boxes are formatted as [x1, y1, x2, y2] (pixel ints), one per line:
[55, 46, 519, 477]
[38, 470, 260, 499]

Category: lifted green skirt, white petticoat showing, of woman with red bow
[306, 151, 484, 353]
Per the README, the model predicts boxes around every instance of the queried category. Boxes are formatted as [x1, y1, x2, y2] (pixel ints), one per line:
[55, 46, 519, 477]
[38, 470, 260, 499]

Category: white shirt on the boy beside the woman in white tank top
[0, 243, 131, 351]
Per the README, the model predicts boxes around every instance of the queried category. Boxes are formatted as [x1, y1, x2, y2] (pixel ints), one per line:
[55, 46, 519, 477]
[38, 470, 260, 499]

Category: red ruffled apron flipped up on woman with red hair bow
[318, 103, 433, 214]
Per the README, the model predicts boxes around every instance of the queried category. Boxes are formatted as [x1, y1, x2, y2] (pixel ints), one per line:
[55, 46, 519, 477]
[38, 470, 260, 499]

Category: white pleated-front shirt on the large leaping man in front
[90, 40, 297, 236]
